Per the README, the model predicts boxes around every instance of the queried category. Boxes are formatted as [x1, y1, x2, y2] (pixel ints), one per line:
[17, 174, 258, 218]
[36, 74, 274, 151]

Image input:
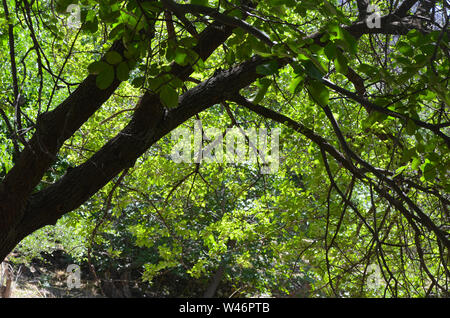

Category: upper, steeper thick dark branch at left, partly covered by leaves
[0, 17, 236, 229]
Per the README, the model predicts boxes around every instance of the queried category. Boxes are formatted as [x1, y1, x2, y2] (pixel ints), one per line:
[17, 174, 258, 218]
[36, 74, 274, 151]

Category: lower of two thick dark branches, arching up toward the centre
[18, 57, 267, 240]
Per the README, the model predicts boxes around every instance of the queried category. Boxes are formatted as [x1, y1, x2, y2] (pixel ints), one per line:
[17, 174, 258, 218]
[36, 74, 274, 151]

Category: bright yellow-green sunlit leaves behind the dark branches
[0, 0, 450, 296]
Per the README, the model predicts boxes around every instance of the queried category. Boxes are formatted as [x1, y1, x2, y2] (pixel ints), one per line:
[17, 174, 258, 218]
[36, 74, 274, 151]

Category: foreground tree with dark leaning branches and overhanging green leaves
[0, 0, 450, 295]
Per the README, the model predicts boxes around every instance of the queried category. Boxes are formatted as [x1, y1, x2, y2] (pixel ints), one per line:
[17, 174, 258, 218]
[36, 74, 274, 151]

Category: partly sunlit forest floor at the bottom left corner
[4, 250, 161, 298]
